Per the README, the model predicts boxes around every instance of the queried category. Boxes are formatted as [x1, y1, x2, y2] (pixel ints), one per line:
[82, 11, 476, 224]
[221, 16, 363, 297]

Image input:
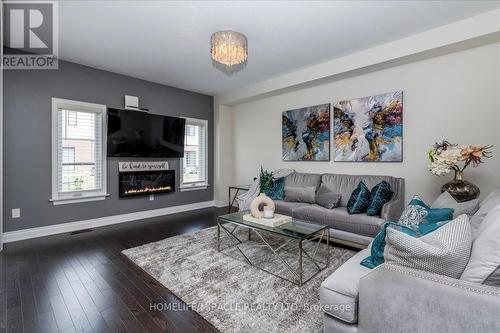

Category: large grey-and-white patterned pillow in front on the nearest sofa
[384, 214, 472, 279]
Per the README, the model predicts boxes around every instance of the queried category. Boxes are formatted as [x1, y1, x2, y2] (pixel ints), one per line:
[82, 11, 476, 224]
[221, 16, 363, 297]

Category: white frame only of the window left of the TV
[50, 97, 109, 205]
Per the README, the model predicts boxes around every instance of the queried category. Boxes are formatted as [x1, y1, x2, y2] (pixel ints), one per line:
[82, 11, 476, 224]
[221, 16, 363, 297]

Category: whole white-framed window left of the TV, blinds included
[52, 98, 106, 204]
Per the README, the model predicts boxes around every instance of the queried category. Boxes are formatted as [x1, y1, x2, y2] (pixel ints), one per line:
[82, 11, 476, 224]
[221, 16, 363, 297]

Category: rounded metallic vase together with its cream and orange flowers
[429, 139, 493, 202]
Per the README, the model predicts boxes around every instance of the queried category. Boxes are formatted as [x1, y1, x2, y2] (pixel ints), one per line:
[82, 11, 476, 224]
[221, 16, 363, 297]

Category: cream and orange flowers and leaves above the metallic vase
[429, 139, 493, 176]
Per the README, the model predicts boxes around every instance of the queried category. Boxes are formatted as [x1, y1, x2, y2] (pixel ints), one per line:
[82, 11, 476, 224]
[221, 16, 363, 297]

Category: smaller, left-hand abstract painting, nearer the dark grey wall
[281, 104, 330, 161]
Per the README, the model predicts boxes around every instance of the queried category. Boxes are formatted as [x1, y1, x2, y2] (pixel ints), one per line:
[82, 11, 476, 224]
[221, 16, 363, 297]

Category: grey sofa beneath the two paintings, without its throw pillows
[274, 172, 405, 248]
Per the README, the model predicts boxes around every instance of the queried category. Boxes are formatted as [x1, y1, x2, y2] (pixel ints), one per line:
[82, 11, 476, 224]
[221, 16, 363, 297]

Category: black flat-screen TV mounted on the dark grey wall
[107, 109, 186, 157]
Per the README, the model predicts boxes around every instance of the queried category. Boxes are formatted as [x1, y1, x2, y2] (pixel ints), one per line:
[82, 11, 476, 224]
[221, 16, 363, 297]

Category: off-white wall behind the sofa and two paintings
[232, 43, 500, 200]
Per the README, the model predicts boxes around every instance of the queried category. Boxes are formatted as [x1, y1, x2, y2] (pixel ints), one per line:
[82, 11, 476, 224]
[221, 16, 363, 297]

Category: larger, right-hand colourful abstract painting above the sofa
[333, 91, 403, 162]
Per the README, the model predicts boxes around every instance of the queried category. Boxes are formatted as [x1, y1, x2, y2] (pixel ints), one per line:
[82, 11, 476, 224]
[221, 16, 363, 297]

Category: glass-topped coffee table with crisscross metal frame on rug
[217, 212, 330, 285]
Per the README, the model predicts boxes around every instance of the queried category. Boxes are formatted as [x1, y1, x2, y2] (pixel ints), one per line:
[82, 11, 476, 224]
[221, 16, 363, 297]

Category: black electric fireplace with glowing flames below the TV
[119, 170, 175, 198]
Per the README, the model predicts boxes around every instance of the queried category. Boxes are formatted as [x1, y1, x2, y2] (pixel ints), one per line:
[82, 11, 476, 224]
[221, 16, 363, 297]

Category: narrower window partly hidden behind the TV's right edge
[181, 118, 208, 190]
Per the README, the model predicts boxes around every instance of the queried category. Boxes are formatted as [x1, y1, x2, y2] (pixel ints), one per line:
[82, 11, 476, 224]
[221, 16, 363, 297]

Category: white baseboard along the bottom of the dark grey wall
[2, 201, 215, 243]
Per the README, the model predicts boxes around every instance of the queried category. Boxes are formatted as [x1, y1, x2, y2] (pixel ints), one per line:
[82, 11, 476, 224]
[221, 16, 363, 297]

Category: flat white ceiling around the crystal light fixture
[59, 1, 500, 95]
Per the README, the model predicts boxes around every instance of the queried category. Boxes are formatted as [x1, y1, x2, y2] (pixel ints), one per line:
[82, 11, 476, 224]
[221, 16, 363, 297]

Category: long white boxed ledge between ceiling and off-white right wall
[216, 9, 500, 106]
